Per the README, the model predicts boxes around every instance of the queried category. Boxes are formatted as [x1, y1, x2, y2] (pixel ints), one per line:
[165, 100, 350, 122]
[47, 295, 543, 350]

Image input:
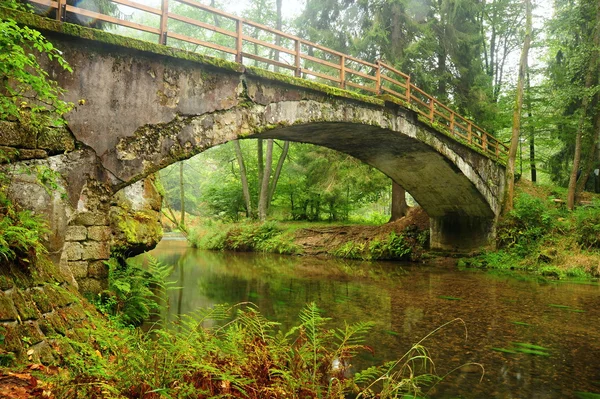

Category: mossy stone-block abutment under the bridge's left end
[0, 121, 162, 294]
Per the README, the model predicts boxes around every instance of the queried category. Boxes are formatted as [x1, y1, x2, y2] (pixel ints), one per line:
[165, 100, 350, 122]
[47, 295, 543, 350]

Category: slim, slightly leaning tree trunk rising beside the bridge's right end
[503, 0, 531, 214]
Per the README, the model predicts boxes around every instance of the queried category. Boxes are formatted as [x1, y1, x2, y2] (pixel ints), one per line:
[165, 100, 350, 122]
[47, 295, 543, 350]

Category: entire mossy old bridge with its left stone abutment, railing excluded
[0, 11, 505, 291]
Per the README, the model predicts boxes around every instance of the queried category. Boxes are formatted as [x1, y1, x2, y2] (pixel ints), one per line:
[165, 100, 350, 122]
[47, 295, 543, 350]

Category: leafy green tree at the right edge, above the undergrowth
[548, 0, 600, 209]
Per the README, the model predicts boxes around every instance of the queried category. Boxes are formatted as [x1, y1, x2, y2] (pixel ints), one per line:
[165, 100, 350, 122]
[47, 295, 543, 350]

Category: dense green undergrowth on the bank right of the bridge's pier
[459, 182, 600, 279]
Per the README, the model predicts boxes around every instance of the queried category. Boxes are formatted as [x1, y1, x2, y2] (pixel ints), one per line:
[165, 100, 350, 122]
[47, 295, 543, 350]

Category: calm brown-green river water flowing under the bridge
[138, 240, 600, 398]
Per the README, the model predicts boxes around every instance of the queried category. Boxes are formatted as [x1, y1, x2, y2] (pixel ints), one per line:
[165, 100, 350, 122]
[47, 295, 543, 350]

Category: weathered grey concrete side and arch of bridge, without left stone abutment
[5, 11, 504, 257]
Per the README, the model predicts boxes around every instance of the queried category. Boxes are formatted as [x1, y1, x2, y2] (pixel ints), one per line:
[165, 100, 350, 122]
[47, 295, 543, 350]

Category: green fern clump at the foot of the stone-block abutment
[94, 256, 171, 327]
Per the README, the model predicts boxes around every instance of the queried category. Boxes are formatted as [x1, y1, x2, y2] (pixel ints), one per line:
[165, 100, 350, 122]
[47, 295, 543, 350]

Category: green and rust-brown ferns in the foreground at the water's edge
[53, 303, 458, 399]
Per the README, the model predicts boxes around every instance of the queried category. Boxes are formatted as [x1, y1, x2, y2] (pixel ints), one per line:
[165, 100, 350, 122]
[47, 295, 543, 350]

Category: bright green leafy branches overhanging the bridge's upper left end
[0, 1, 73, 128]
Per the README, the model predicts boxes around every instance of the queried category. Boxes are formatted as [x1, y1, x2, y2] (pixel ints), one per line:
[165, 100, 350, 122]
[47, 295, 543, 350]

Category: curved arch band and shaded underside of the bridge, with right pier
[108, 100, 503, 251]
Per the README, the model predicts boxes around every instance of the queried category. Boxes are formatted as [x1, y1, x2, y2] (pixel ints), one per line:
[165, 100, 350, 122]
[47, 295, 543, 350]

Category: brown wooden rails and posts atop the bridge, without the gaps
[29, 0, 508, 160]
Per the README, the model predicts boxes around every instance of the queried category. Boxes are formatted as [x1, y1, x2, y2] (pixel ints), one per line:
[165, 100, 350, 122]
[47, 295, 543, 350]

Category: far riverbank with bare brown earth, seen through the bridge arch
[188, 207, 429, 261]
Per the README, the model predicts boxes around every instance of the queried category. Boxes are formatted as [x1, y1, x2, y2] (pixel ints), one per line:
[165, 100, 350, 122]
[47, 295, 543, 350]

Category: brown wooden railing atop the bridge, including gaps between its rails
[29, 0, 508, 160]
